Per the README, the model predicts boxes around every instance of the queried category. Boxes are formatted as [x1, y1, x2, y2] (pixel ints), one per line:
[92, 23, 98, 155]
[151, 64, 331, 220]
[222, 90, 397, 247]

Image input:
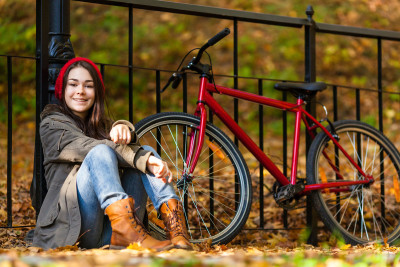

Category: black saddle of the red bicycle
[274, 82, 326, 97]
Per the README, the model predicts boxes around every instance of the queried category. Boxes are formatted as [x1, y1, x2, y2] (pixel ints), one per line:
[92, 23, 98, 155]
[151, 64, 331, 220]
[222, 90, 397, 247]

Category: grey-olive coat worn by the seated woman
[33, 105, 151, 249]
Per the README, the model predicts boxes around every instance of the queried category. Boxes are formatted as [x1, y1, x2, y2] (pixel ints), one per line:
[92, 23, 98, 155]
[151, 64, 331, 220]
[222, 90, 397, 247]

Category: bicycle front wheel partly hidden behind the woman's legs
[135, 113, 251, 244]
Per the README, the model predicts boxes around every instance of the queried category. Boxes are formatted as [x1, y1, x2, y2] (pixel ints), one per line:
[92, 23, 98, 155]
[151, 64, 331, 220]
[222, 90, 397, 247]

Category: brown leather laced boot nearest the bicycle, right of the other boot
[160, 199, 193, 250]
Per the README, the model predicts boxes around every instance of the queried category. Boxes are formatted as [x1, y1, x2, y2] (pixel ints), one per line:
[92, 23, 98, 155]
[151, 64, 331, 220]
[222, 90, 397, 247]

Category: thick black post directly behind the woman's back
[31, 0, 75, 214]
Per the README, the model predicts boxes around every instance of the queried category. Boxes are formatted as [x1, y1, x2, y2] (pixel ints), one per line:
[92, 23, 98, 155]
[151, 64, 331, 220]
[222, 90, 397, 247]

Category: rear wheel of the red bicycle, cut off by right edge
[307, 121, 400, 245]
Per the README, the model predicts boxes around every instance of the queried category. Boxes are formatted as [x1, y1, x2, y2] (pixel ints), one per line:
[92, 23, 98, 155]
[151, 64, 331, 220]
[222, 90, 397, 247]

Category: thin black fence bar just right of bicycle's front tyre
[258, 79, 264, 228]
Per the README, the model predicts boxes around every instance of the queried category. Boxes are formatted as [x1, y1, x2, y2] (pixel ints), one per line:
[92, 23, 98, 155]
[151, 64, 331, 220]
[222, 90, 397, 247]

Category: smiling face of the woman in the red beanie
[65, 67, 95, 119]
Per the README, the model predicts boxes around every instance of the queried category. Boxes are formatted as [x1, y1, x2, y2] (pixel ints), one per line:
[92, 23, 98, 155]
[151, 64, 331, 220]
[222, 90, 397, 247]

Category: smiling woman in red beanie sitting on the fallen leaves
[33, 58, 191, 251]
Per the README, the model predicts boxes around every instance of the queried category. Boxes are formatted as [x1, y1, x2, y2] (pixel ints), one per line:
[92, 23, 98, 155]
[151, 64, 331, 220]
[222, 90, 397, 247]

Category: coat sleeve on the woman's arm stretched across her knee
[40, 118, 152, 172]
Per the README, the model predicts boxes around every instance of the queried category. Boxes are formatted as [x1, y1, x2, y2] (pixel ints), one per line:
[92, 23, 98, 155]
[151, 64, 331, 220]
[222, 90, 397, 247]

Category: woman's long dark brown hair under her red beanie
[60, 61, 111, 140]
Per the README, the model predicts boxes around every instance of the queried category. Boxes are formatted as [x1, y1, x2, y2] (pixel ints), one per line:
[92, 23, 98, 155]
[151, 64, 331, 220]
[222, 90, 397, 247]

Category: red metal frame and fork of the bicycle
[186, 76, 374, 193]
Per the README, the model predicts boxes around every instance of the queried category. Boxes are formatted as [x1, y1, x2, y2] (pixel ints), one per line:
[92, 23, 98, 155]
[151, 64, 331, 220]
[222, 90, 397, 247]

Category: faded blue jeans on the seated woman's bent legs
[76, 145, 179, 248]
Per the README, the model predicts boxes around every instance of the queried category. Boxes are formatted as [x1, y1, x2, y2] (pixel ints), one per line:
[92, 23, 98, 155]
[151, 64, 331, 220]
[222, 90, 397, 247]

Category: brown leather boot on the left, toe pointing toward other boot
[105, 197, 174, 251]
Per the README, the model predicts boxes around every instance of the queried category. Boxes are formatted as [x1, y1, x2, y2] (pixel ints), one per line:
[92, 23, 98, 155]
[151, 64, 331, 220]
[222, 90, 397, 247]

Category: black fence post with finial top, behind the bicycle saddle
[304, 6, 318, 246]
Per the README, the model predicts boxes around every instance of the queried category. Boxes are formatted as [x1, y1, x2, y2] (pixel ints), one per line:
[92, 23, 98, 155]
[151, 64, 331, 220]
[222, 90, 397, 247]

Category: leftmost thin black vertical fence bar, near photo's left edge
[7, 56, 12, 227]
